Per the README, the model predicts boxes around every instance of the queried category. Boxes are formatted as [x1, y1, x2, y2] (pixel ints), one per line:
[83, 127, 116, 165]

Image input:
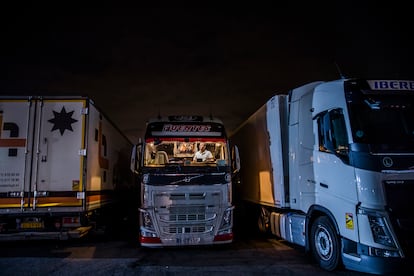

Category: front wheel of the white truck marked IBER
[310, 216, 341, 271]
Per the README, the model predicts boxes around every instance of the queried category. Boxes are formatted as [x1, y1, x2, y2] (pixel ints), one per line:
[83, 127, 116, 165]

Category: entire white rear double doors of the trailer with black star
[0, 98, 87, 213]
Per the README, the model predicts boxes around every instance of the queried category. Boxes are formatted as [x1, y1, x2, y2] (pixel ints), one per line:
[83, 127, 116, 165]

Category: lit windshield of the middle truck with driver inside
[144, 138, 229, 167]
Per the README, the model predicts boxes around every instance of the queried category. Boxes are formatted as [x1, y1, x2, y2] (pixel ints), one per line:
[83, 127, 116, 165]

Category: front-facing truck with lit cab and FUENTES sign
[131, 116, 234, 247]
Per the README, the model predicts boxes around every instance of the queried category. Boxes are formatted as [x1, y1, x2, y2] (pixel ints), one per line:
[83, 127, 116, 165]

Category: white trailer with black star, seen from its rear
[0, 96, 138, 240]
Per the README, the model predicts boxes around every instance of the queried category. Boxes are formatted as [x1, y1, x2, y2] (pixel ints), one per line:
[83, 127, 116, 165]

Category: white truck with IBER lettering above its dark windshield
[230, 79, 414, 274]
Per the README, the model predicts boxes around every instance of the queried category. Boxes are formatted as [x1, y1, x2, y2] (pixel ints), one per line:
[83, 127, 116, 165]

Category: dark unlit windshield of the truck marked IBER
[350, 95, 414, 151]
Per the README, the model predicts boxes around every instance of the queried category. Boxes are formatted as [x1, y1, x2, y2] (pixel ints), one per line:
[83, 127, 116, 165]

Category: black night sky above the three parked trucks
[0, 1, 414, 142]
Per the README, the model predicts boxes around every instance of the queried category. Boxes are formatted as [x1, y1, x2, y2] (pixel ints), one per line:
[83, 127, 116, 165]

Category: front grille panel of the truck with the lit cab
[141, 175, 232, 246]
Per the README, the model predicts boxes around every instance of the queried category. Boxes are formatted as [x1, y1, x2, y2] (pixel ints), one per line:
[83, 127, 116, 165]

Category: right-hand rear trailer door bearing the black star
[30, 99, 86, 209]
